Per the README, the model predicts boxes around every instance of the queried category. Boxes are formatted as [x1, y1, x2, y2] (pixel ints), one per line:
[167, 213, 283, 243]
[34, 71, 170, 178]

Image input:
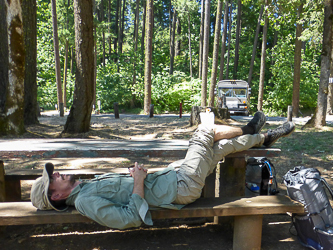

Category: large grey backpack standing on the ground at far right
[283, 166, 333, 250]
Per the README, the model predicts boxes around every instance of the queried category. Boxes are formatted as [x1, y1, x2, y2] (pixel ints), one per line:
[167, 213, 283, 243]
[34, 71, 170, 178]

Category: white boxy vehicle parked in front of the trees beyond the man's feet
[217, 80, 251, 115]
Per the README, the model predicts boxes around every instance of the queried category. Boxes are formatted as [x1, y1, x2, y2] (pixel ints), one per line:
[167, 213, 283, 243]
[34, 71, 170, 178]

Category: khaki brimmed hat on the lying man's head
[30, 162, 67, 211]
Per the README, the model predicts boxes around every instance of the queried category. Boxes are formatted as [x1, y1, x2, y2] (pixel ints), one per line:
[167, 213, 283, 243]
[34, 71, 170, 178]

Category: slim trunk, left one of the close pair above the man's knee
[201, 1, 210, 107]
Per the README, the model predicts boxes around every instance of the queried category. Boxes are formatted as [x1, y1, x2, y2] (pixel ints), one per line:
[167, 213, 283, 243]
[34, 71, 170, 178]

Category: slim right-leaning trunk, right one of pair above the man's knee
[208, 0, 222, 107]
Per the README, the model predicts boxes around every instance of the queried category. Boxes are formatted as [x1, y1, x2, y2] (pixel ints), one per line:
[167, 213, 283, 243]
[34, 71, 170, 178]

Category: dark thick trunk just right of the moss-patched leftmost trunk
[22, 0, 39, 125]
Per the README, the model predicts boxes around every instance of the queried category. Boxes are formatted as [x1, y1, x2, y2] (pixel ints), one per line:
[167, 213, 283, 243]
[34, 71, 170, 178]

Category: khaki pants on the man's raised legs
[170, 125, 265, 204]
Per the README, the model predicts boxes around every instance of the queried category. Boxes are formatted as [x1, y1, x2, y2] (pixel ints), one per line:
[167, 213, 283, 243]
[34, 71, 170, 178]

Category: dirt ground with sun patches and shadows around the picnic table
[0, 112, 333, 250]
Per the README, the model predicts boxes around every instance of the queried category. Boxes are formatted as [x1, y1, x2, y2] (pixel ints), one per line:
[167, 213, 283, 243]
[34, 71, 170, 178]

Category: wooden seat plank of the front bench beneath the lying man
[0, 195, 304, 226]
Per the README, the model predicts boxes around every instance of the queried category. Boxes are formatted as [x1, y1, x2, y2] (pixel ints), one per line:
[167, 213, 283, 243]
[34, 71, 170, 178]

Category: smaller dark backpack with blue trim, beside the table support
[245, 157, 279, 197]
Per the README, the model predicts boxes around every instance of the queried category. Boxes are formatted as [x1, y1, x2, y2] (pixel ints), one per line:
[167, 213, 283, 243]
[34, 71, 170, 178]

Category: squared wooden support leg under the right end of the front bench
[233, 215, 263, 250]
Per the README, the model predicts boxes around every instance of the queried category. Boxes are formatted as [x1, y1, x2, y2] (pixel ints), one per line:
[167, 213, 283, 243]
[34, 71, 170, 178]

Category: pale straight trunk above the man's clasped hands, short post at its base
[144, 0, 154, 114]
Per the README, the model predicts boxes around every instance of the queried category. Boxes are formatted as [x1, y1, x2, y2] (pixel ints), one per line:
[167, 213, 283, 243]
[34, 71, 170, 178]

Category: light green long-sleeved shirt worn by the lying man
[66, 167, 183, 229]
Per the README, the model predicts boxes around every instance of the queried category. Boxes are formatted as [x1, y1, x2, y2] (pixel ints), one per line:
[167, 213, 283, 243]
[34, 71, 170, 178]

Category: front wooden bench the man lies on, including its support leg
[0, 195, 304, 250]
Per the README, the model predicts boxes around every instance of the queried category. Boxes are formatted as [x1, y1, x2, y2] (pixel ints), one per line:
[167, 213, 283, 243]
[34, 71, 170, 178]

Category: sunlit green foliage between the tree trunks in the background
[37, 0, 323, 115]
